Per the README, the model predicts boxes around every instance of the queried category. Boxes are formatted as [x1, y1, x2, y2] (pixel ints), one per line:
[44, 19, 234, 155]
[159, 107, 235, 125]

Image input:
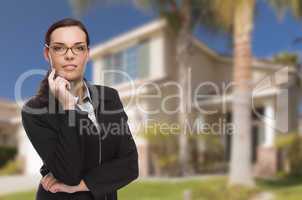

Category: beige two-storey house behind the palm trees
[91, 19, 299, 176]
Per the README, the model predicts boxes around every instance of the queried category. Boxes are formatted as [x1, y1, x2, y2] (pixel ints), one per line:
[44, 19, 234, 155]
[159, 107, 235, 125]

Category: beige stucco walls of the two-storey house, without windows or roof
[89, 21, 299, 177]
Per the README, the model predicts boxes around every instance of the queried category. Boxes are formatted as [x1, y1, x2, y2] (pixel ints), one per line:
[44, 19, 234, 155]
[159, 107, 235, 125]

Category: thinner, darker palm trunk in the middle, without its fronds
[176, 0, 193, 175]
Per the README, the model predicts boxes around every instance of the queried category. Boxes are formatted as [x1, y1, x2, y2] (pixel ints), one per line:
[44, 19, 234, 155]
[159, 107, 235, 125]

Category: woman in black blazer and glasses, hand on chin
[22, 18, 138, 200]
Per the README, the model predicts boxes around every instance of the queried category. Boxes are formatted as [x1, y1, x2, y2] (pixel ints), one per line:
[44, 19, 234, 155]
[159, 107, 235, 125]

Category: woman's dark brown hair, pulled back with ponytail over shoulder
[36, 18, 90, 106]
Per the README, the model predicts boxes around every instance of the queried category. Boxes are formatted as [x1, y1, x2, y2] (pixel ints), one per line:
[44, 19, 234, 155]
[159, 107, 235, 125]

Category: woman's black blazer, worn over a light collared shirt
[21, 79, 139, 200]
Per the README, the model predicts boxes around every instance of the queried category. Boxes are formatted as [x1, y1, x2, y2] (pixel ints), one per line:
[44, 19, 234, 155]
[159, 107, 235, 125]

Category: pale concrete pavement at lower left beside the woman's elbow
[0, 175, 41, 196]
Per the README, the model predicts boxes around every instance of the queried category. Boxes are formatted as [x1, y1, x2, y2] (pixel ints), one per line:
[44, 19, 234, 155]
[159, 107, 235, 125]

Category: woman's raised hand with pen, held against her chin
[48, 68, 76, 110]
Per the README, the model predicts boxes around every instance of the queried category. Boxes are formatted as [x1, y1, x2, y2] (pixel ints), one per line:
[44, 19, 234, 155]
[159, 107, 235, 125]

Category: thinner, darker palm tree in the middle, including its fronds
[70, 0, 228, 175]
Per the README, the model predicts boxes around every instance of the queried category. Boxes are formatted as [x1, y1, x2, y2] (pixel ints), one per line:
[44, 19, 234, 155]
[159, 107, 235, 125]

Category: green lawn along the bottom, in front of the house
[0, 178, 302, 200]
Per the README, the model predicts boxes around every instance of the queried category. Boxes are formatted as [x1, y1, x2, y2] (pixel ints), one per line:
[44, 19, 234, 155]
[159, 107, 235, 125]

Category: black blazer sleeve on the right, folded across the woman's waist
[83, 90, 139, 199]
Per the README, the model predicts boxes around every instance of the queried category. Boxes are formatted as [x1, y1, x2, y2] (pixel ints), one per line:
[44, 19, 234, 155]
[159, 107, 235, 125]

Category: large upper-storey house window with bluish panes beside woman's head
[104, 40, 150, 85]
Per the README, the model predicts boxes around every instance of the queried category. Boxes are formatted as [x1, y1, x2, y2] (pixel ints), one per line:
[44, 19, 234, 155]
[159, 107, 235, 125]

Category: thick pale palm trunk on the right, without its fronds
[229, 0, 255, 186]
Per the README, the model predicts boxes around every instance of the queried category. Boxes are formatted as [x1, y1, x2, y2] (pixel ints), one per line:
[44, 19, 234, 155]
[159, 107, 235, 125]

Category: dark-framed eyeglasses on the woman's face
[44, 44, 88, 56]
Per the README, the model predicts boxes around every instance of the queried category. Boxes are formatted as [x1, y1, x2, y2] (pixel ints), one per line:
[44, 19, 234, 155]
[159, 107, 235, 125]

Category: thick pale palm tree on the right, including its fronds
[213, 0, 302, 186]
